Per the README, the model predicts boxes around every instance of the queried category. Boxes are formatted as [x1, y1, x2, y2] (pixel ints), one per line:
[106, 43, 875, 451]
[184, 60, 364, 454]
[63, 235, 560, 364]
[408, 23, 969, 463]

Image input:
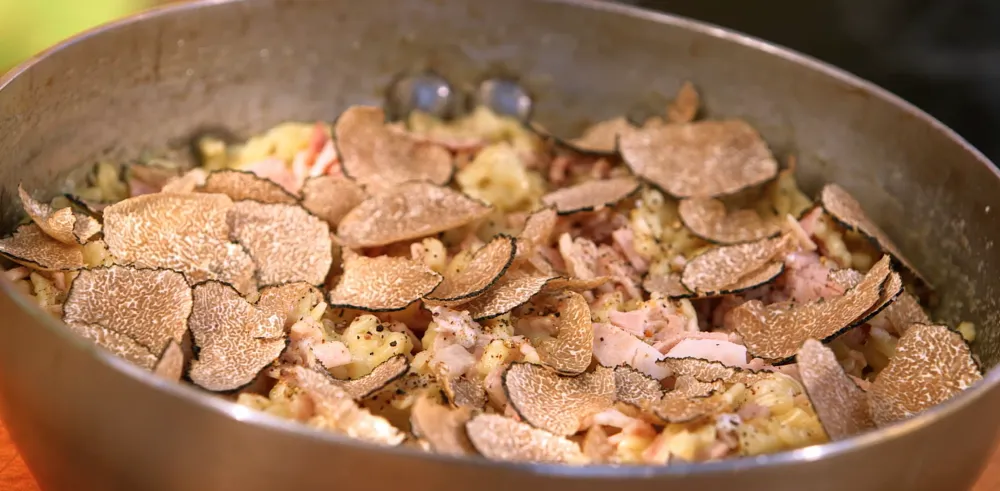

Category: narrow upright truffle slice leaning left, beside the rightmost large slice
[795, 339, 875, 440]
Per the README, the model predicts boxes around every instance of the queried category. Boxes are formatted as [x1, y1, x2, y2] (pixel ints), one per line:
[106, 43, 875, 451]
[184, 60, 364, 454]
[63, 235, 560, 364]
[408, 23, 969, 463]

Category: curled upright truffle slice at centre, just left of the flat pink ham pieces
[536, 292, 594, 375]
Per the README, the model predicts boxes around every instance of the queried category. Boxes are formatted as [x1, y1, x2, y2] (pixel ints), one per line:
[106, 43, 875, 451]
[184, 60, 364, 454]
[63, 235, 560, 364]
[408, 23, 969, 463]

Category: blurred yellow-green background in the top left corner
[0, 0, 160, 73]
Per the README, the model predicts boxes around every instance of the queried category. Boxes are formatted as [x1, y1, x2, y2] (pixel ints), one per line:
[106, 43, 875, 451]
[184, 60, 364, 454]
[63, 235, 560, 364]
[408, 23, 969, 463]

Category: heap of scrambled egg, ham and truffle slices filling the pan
[0, 85, 981, 465]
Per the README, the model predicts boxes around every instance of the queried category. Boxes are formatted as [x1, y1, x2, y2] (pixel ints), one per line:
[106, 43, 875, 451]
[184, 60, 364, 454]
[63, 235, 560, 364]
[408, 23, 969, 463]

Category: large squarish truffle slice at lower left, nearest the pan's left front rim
[63, 266, 192, 353]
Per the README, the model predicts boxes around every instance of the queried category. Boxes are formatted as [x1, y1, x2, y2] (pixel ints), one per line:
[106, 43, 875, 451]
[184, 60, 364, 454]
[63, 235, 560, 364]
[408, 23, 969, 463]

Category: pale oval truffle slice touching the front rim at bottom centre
[465, 414, 586, 464]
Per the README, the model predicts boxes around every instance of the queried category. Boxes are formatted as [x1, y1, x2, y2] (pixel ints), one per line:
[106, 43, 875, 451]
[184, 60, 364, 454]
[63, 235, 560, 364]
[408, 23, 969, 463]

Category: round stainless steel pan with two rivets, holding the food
[0, 0, 1000, 491]
